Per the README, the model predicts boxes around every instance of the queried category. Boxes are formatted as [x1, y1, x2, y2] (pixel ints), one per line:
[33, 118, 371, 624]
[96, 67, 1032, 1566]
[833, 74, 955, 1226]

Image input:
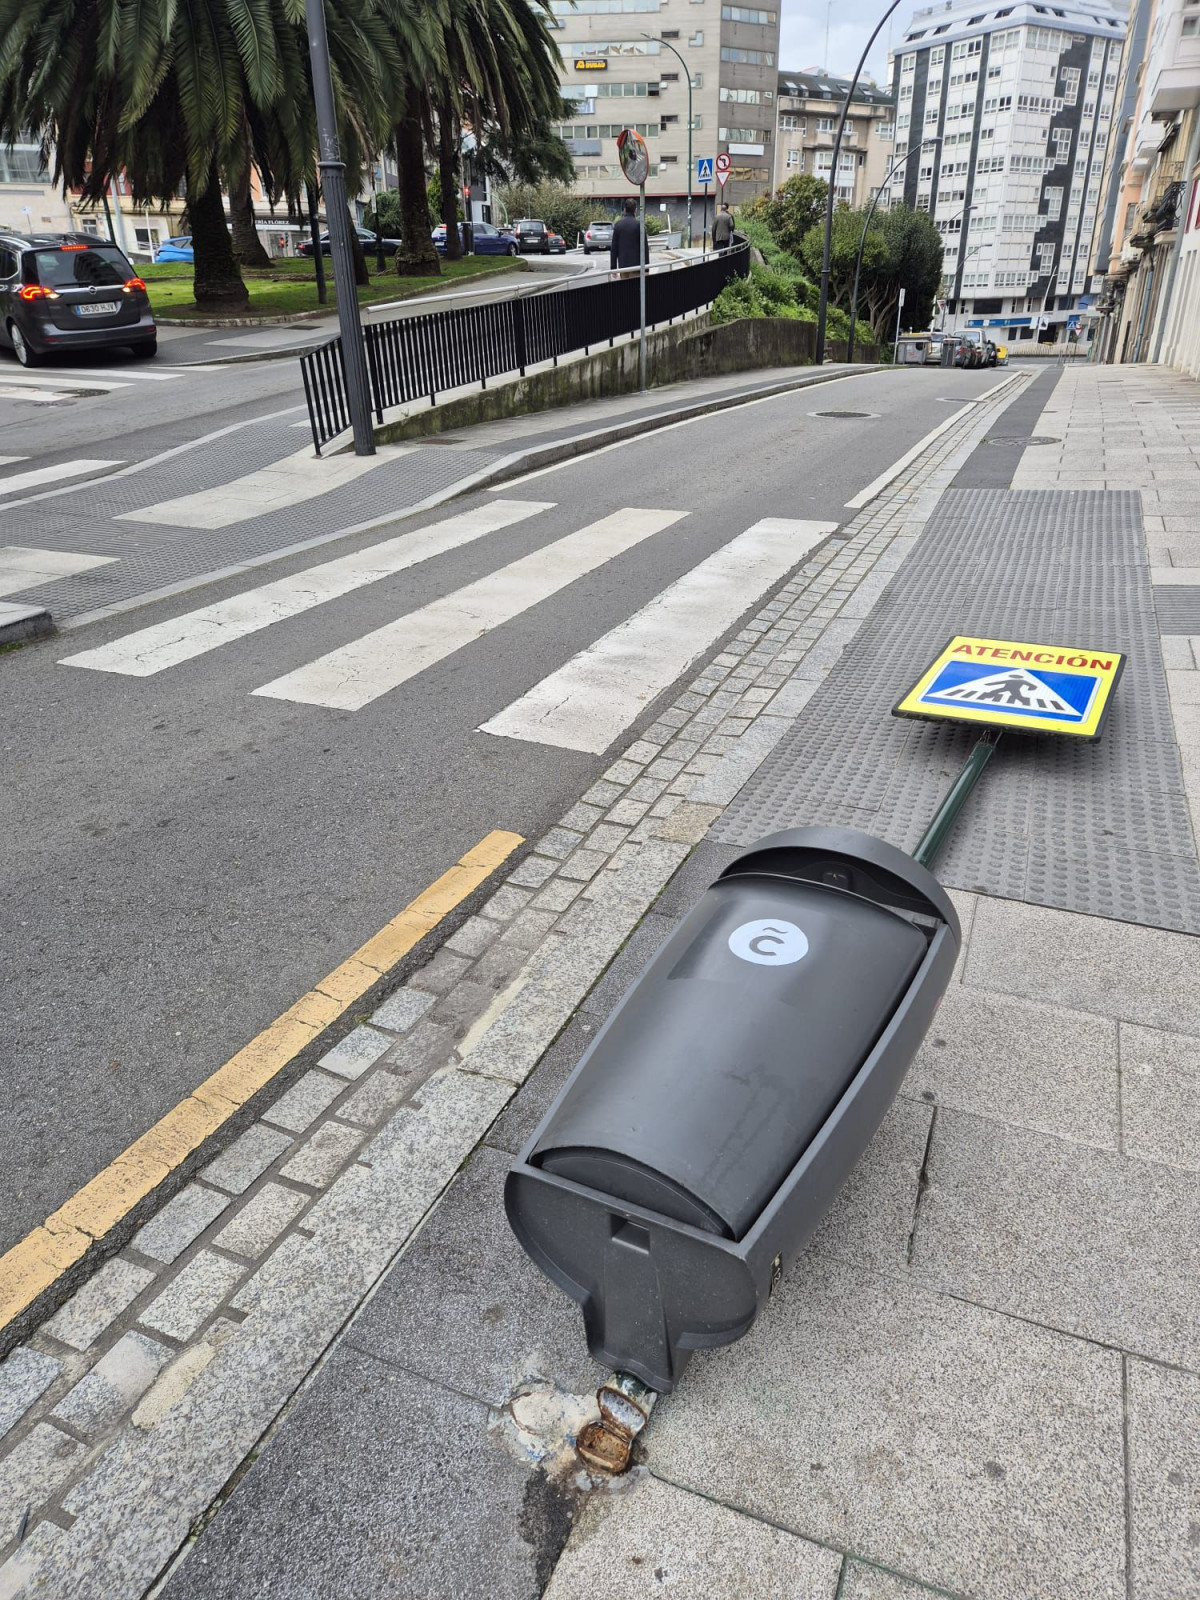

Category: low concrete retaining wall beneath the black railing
[376, 312, 877, 443]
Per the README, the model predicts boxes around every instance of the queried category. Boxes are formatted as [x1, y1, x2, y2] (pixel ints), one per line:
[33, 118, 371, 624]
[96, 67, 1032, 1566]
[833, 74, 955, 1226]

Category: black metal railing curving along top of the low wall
[301, 242, 750, 454]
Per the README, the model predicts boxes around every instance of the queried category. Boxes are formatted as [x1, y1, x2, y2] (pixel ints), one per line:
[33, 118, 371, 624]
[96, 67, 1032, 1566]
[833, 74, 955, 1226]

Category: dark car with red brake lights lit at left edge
[0, 232, 158, 366]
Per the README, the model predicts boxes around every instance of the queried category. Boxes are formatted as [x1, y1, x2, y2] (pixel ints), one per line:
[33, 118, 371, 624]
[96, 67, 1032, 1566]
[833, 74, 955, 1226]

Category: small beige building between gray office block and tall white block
[774, 67, 896, 206]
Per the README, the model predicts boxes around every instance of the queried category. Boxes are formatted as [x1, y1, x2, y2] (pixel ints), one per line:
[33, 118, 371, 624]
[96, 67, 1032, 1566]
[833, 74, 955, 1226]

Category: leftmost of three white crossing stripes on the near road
[61, 499, 554, 678]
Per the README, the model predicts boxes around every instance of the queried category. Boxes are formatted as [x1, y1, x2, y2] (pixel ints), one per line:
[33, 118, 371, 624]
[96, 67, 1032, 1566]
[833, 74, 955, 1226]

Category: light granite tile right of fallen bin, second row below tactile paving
[904, 984, 1120, 1150]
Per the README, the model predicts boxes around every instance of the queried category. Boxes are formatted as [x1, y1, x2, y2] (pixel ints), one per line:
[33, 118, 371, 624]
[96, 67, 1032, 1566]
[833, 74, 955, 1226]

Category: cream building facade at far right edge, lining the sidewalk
[1093, 0, 1200, 378]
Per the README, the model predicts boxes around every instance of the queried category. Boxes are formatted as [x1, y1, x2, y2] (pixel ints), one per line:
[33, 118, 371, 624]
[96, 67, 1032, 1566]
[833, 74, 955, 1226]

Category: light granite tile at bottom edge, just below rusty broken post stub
[542, 1474, 842, 1600]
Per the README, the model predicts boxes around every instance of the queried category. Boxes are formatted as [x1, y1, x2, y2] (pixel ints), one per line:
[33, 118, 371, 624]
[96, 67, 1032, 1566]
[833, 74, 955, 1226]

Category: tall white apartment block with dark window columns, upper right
[893, 0, 1126, 342]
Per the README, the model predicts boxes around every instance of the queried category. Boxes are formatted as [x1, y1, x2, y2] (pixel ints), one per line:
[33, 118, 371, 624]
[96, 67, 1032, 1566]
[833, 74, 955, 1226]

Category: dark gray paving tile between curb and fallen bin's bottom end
[346, 1147, 603, 1406]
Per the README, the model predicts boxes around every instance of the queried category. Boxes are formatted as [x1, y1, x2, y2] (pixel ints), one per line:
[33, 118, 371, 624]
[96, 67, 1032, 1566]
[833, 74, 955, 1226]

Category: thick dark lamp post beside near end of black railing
[304, 0, 374, 456]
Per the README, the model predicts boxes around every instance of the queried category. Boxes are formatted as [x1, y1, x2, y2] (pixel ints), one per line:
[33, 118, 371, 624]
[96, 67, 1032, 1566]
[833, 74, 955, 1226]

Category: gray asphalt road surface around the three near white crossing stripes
[0, 366, 1002, 1248]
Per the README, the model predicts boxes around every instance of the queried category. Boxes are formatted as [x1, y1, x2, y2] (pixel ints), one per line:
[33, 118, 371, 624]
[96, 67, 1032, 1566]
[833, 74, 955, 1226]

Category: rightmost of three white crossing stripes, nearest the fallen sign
[480, 517, 837, 755]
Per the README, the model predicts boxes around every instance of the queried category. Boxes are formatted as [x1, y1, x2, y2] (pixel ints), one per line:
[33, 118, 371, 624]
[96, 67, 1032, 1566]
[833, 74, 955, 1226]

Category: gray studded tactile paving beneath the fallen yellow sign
[712, 488, 1200, 933]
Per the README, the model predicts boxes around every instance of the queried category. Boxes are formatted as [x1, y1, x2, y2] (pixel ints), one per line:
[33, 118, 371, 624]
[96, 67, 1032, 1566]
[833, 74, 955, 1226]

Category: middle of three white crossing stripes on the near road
[254, 507, 686, 710]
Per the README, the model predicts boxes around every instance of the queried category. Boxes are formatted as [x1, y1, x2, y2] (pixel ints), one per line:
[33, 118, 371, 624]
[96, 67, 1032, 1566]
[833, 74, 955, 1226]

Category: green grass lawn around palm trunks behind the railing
[139, 256, 523, 320]
